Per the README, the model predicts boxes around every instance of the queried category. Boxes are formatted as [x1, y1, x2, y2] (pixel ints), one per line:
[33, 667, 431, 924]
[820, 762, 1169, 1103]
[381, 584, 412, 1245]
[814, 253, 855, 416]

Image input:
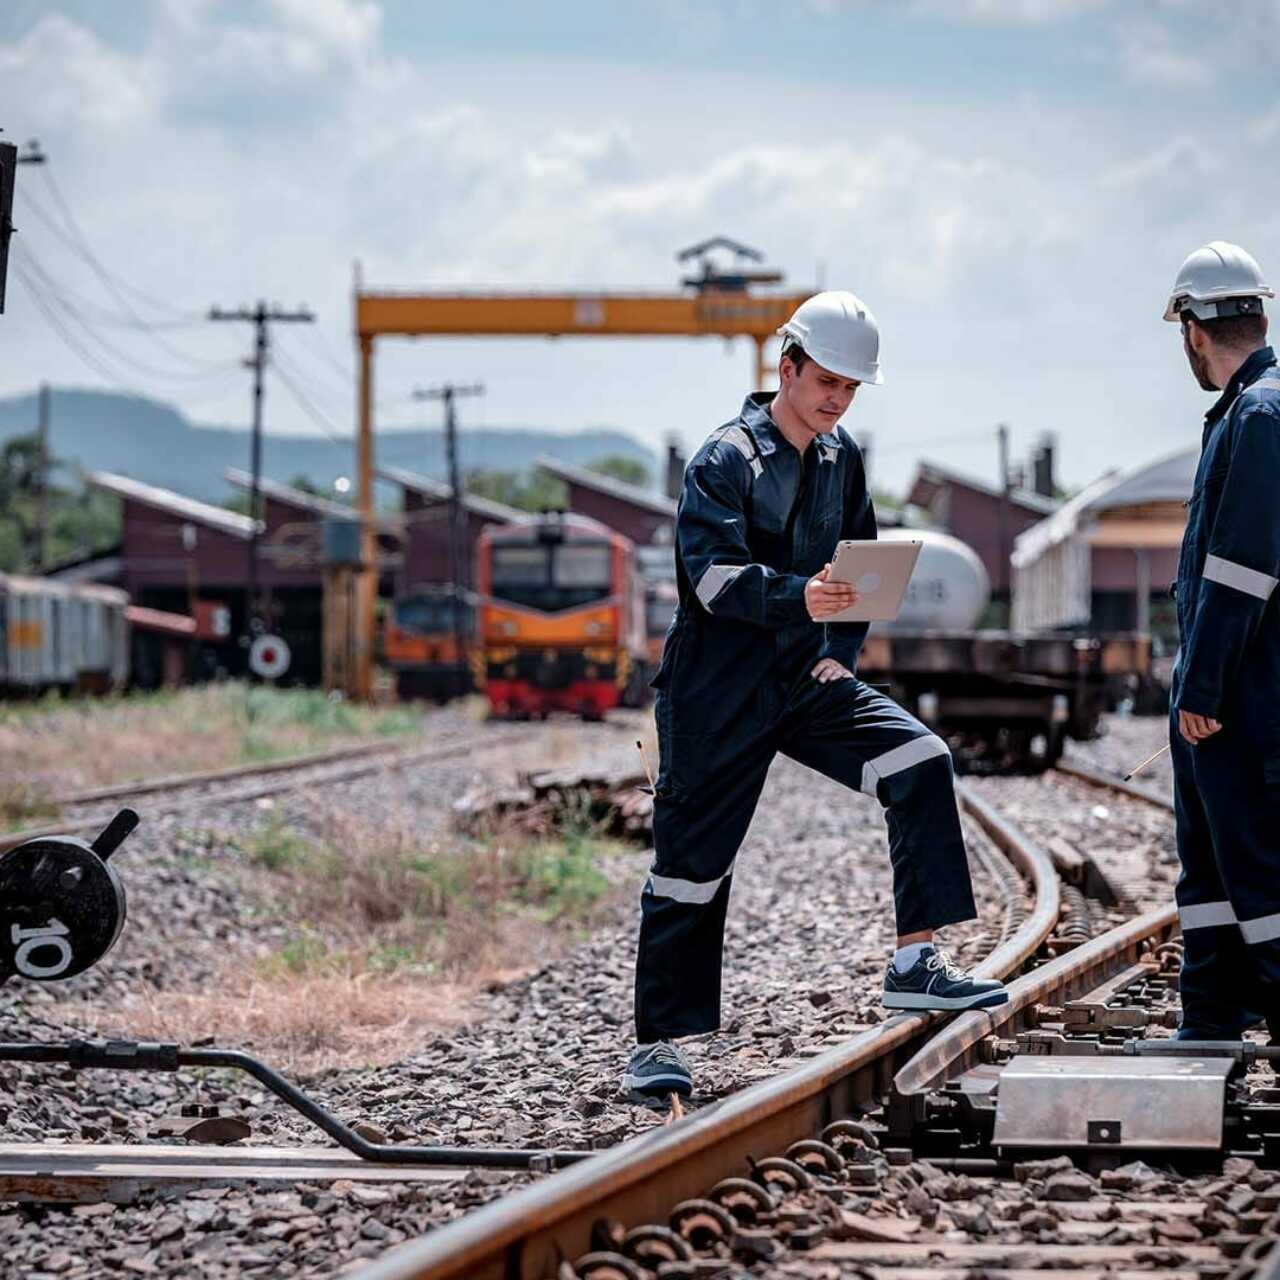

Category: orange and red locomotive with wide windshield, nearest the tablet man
[474, 512, 646, 719]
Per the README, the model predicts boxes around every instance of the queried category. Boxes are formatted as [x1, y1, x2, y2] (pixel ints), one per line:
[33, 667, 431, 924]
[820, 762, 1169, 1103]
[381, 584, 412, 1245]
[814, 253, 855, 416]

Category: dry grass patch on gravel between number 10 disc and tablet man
[93, 812, 622, 1075]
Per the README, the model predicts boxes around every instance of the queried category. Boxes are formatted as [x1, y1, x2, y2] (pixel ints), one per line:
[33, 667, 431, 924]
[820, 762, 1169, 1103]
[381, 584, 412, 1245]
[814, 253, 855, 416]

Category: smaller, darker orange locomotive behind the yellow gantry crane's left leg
[383, 584, 475, 703]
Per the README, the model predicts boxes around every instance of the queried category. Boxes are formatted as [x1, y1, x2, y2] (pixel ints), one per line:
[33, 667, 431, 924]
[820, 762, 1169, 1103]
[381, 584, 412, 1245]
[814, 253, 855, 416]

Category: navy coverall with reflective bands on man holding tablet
[636, 393, 975, 1043]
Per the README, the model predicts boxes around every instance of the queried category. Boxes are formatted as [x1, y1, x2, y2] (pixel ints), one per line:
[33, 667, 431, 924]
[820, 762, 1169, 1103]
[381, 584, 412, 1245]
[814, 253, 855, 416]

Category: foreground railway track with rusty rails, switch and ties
[343, 768, 1280, 1280]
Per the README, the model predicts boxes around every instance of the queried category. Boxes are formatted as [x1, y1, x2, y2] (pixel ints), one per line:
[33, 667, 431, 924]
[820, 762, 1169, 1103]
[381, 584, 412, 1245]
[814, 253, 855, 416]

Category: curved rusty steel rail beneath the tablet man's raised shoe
[348, 786, 1057, 1280]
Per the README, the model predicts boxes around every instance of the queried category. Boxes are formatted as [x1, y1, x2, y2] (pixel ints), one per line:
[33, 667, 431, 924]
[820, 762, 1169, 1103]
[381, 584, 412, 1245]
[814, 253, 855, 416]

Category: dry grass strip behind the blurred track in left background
[0, 684, 421, 795]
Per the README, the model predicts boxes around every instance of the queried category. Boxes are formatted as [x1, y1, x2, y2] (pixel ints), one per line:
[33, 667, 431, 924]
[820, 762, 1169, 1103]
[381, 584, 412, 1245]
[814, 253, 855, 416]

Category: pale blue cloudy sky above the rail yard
[0, 0, 1280, 488]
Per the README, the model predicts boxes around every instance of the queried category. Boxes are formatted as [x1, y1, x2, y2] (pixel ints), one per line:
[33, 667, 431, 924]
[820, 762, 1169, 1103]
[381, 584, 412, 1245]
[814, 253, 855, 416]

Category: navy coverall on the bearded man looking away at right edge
[1170, 347, 1280, 1037]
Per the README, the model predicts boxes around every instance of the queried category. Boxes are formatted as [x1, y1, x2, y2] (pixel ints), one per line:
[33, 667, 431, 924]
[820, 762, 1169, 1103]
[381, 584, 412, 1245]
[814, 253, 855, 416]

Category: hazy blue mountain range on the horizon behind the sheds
[0, 387, 658, 503]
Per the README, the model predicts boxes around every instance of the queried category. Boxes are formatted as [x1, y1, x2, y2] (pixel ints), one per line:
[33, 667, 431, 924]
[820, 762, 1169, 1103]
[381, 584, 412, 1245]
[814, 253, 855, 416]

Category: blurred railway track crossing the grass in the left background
[0, 732, 508, 854]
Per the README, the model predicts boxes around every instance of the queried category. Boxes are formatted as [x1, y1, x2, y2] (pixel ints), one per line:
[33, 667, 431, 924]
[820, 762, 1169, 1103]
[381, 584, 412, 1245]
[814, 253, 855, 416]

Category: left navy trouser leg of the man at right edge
[1170, 712, 1252, 1039]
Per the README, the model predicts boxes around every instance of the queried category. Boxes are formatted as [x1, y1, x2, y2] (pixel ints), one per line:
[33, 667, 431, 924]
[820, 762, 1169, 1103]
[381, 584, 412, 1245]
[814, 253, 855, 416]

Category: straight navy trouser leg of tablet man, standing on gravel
[635, 733, 773, 1043]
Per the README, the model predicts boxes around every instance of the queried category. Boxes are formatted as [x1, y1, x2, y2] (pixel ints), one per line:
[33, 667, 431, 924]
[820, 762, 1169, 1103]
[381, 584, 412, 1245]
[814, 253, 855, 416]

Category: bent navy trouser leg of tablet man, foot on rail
[781, 680, 977, 934]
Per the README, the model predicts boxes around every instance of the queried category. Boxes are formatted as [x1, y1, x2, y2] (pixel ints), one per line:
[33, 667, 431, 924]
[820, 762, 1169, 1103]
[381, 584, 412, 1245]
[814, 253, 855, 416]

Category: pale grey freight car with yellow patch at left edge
[0, 573, 129, 694]
